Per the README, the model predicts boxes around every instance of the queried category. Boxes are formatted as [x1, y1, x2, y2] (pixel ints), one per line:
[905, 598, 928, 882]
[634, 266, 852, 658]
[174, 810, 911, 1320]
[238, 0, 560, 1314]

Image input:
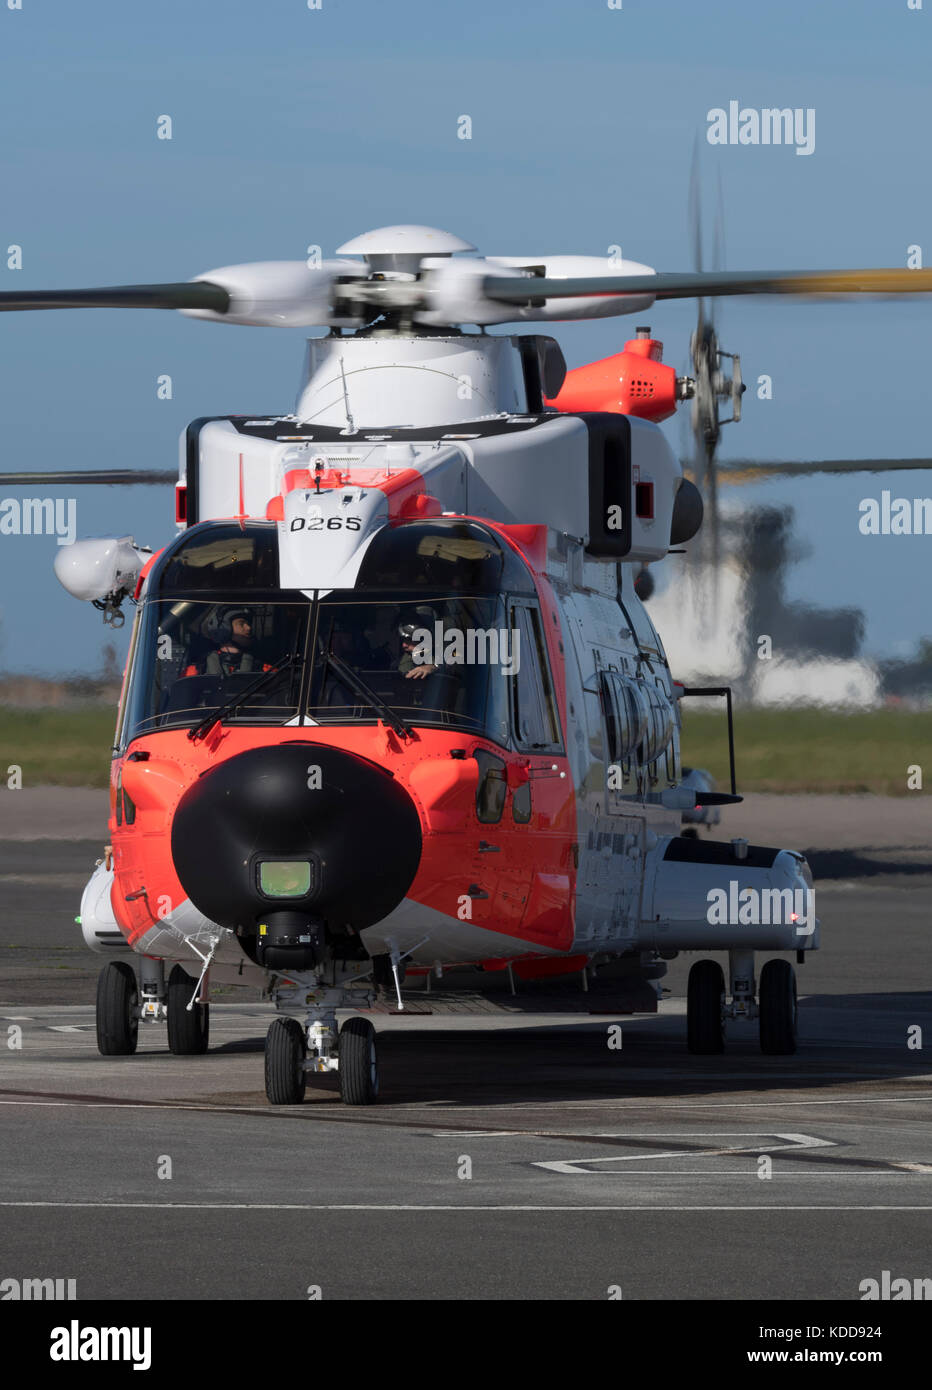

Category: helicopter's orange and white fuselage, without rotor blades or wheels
[82, 358, 815, 980]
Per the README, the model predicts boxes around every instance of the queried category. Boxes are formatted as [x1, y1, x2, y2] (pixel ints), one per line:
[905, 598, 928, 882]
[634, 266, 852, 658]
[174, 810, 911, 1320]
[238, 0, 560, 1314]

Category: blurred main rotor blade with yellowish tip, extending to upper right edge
[482, 268, 932, 304]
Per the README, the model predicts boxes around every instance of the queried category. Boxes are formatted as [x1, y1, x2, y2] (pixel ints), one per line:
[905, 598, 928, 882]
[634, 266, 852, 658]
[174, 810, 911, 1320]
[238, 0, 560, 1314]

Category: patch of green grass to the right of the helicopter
[682, 701, 932, 796]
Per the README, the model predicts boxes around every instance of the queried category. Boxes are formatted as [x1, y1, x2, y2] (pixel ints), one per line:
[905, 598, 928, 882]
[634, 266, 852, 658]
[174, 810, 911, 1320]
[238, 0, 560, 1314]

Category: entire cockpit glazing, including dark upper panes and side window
[119, 518, 538, 746]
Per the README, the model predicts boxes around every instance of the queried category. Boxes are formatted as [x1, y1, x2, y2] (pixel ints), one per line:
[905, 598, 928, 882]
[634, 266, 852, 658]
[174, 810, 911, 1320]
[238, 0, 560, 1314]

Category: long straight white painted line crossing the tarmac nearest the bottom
[0, 1201, 932, 1213]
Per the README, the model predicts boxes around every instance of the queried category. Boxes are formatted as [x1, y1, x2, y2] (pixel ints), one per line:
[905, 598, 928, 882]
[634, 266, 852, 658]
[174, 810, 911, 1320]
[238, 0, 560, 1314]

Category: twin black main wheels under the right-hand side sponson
[686, 951, 797, 1056]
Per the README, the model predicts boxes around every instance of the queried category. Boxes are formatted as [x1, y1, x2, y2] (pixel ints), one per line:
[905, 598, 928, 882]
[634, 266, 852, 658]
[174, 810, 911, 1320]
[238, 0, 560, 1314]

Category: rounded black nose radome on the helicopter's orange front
[171, 742, 421, 931]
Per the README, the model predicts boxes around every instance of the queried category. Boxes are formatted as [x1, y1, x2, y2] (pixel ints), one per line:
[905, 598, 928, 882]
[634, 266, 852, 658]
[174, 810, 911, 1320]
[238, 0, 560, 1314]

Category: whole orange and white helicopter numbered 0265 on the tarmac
[0, 225, 932, 1105]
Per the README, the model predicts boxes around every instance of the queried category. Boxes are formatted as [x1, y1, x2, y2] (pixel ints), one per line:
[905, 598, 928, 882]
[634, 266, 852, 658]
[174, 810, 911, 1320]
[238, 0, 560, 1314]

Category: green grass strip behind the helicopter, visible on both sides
[0, 702, 932, 796]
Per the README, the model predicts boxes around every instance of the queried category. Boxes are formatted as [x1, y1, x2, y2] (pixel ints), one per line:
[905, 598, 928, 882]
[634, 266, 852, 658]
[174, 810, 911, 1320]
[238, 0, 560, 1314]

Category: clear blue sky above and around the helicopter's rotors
[0, 0, 932, 674]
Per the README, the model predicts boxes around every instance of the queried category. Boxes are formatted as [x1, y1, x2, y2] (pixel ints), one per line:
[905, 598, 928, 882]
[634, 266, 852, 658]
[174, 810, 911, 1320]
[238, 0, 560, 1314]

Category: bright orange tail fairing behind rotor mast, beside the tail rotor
[546, 338, 678, 421]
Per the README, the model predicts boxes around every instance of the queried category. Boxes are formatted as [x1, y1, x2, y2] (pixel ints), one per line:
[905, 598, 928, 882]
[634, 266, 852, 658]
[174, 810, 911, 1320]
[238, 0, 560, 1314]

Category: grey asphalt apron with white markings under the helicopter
[0, 798, 932, 1301]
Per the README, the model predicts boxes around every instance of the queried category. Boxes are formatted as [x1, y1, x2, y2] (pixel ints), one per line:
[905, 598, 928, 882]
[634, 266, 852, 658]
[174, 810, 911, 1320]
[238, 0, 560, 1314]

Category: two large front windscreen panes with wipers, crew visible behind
[122, 591, 514, 746]
